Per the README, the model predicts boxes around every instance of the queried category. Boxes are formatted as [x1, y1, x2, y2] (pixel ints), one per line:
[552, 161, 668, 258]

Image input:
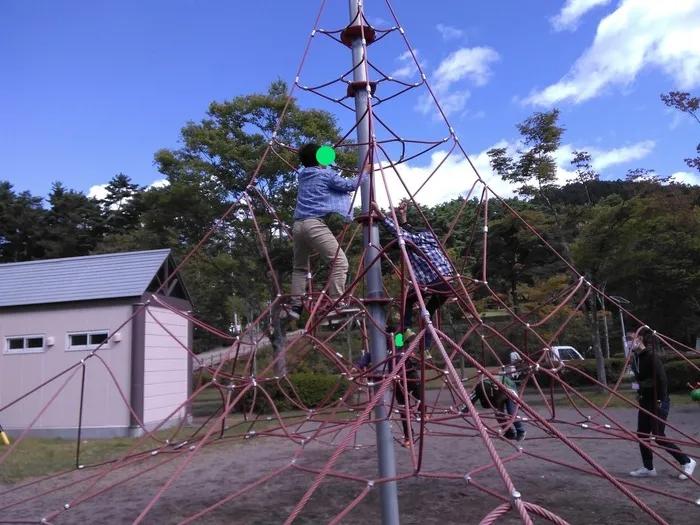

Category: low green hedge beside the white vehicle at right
[537, 358, 700, 393]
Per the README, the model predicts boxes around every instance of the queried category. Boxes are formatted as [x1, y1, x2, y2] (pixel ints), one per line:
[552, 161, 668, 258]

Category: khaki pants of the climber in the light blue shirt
[291, 219, 348, 305]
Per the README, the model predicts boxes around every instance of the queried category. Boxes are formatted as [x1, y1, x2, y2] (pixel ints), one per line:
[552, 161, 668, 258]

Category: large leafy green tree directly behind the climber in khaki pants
[114, 81, 356, 360]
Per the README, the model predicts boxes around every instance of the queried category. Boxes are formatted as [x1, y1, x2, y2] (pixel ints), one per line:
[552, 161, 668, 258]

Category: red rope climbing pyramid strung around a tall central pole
[0, 0, 700, 525]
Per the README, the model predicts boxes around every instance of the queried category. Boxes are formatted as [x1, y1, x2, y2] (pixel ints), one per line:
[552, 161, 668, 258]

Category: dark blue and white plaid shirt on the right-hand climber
[383, 217, 453, 285]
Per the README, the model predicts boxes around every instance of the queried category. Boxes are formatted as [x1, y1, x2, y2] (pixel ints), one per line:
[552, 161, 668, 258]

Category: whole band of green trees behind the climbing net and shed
[0, 87, 700, 360]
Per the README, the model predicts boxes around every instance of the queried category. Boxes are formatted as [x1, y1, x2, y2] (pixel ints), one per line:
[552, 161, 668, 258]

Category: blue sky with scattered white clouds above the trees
[0, 0, 700, 202]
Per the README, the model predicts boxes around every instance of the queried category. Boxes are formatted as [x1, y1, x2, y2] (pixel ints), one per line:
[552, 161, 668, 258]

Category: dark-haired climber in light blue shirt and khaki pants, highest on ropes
[287, 143, 371, 319]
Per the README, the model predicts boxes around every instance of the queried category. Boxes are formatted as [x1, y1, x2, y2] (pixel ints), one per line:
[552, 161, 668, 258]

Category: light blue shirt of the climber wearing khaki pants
[294, 166, 366, 222]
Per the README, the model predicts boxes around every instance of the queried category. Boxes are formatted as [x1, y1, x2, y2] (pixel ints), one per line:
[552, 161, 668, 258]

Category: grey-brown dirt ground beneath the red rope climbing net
[0, 407, 700, 525]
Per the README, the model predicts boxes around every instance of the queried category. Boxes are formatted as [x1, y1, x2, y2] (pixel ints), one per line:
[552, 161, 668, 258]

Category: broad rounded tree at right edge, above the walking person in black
[573, 187, 700, 344]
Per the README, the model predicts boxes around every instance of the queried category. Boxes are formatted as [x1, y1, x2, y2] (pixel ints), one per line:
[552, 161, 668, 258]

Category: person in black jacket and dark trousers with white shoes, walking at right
[627, 332, 696, 480]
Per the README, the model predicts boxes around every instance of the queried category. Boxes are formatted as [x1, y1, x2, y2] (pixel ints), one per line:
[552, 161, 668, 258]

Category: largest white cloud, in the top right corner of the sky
[525, 0, 700, 106]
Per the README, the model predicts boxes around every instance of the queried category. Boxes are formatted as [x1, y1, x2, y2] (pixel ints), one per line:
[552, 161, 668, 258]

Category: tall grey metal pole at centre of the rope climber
[348, 0, 399, 525]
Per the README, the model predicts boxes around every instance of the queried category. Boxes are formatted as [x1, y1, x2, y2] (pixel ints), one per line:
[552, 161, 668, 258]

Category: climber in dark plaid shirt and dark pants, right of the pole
[372, 202, 454, 353]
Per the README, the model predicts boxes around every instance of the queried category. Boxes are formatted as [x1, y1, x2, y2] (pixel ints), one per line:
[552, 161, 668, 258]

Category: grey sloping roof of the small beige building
[0, 249, 189, 308]
